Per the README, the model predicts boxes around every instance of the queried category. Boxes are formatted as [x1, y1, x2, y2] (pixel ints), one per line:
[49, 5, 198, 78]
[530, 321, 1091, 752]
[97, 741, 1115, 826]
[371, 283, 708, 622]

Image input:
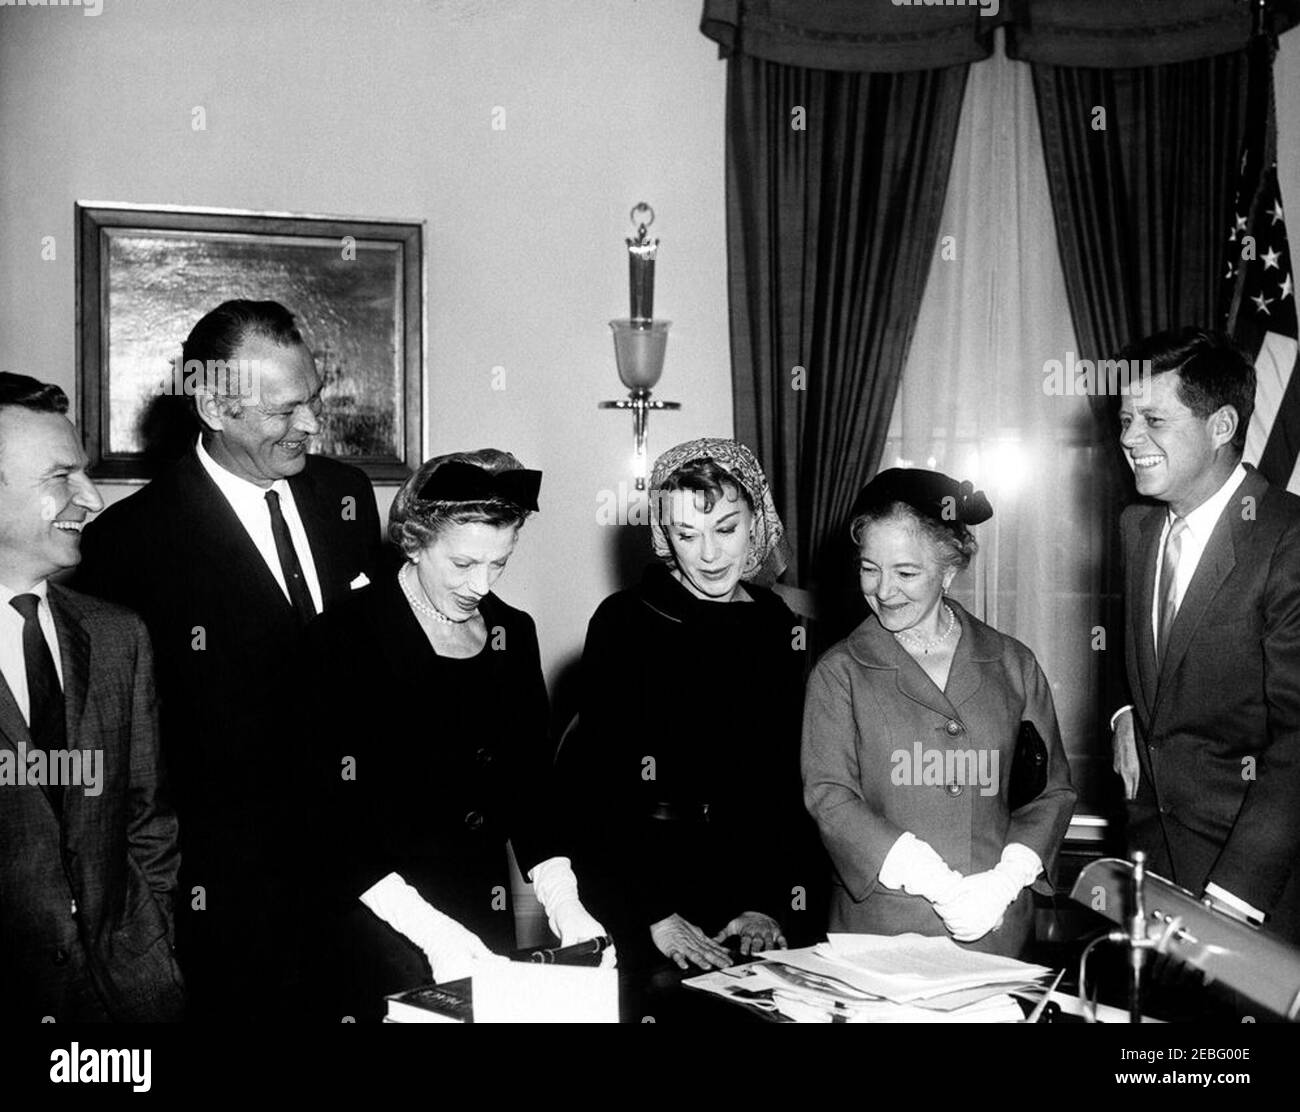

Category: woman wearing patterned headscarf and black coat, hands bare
[560, 438, 806, 969]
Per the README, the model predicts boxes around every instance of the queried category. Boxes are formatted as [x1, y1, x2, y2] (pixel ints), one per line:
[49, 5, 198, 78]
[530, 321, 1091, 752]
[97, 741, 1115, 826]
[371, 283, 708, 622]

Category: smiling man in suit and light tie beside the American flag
[1112, 329, 1300, 942]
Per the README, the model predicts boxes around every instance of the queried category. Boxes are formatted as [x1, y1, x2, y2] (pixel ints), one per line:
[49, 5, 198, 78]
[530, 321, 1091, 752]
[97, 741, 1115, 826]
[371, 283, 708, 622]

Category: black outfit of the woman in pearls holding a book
[306, 574, 563, 1022]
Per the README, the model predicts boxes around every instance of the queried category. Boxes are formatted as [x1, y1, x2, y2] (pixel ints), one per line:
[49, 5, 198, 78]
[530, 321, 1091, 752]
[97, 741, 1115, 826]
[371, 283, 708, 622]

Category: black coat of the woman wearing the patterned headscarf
[559, 563, 826, 964]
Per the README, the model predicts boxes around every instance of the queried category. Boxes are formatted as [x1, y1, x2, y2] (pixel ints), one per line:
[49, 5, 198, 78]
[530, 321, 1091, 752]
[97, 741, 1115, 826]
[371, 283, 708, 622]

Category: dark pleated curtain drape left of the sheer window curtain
[727, 55, 967, 603]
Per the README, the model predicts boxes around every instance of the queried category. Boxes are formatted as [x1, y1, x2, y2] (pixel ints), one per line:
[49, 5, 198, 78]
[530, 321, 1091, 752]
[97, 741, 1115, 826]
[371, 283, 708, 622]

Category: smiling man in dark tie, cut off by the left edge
[0, 373, 185, 1024]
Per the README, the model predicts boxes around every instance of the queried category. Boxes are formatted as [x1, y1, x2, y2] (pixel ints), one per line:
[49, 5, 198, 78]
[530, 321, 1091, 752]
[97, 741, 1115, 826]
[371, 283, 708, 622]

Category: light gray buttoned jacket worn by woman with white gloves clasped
[803, 602, 1075, 955]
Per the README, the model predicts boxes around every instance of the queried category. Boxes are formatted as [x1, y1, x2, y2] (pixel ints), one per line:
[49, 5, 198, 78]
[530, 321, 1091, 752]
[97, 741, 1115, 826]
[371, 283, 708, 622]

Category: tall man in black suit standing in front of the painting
[77, 300, 380, 1020]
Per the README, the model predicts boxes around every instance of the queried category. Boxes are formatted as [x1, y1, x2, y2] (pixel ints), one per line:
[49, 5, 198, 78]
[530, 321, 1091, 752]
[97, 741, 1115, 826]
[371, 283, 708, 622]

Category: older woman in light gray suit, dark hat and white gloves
[802, 468, 1075, 955]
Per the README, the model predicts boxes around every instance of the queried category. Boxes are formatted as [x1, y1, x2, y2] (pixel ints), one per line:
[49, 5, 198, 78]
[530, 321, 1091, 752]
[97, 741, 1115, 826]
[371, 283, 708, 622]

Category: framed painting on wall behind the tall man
[77, 202, 424, 483]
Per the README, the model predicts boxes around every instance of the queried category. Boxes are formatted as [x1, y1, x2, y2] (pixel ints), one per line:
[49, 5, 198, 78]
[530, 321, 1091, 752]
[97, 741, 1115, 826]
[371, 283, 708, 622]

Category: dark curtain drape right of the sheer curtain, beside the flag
[1034, 49, 1251, 736]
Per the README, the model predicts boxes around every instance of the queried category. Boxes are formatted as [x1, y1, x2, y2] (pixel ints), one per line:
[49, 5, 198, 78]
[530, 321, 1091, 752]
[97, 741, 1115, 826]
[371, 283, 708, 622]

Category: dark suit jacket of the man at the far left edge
[0, 585, 183, 1022]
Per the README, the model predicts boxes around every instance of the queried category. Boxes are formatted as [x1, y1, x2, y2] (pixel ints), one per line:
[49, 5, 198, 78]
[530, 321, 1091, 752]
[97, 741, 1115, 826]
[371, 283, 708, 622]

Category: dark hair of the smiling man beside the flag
[1122, 328, 1255, 453]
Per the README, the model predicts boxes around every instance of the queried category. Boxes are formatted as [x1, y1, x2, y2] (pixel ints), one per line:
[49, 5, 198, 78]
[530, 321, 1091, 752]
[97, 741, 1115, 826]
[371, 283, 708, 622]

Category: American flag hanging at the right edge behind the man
[1225, 35, 1300, 494]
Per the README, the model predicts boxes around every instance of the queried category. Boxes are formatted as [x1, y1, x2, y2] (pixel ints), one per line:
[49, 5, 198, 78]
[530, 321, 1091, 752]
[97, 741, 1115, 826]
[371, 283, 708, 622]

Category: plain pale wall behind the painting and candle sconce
[0, 0, 732, 702]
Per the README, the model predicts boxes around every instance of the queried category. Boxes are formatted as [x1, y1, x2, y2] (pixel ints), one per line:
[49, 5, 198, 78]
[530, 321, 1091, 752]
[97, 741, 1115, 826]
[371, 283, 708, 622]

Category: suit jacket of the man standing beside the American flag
[1121, 468, 1300, 940]
